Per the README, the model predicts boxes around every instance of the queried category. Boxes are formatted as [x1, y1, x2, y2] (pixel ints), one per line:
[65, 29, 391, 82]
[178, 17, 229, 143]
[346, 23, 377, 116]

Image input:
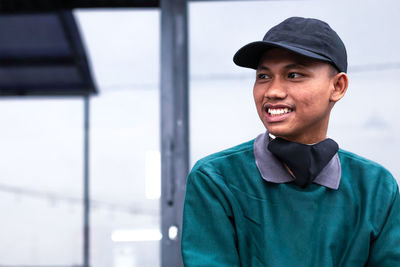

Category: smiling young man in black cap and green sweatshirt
[182, 17, 400, 267]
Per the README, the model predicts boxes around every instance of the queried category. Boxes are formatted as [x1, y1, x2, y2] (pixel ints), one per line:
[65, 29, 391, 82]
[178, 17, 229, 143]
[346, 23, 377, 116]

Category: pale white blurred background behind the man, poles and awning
[0, 0, 400, 267]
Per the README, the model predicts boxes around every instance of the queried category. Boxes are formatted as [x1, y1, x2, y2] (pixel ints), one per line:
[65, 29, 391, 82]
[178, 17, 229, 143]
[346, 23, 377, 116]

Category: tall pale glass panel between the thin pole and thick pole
[75, 10, 161, 267]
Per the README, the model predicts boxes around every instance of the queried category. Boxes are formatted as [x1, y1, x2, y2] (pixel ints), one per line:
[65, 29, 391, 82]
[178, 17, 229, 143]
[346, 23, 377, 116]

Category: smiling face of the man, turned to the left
[253, 48, 335, 144]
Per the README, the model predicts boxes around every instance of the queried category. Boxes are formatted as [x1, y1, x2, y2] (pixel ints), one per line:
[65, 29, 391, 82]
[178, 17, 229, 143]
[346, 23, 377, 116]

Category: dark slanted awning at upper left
[0, 12, 96, 96]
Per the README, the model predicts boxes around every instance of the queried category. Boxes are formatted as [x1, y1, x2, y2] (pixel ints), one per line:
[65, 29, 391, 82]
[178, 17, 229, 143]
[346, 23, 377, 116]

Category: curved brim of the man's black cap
[233, 41, 332, 69]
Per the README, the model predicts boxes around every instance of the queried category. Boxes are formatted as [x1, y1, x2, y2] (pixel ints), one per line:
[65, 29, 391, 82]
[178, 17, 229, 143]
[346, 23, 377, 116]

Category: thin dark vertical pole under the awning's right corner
[83, 96, 90, 267]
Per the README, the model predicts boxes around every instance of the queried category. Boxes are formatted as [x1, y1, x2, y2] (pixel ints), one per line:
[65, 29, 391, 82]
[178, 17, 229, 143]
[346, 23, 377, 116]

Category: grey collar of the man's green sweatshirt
[254, 132, 342, 189]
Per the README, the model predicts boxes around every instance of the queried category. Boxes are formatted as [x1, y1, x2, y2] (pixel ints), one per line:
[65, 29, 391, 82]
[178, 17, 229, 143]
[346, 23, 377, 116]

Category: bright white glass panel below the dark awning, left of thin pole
[0, 99, 83, 266]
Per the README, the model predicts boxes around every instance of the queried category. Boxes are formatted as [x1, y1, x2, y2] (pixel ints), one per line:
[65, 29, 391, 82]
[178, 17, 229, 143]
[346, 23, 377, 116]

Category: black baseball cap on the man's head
[233, 17, 347, 72]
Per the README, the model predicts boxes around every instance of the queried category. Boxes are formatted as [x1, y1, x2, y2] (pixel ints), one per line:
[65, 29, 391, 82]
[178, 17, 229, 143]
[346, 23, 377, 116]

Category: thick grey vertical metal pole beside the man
[160, 0, 189, 267]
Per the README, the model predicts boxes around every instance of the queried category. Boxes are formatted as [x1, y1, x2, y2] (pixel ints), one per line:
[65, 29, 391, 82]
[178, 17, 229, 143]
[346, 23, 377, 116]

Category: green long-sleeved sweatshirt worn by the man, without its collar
[182, 141, 400, 267]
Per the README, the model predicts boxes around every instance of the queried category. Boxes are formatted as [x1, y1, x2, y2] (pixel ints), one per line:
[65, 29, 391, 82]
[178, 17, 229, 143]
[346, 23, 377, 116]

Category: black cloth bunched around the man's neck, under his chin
[268, 137, 339, 188]
